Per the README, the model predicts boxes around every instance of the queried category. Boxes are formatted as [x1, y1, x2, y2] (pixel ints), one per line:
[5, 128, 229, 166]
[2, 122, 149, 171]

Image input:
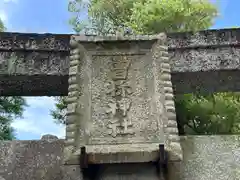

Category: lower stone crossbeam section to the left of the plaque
[0, 140, 64, 180]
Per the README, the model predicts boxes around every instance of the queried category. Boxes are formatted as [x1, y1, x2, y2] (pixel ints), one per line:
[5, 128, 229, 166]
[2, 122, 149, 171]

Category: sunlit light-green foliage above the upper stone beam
[69, 0, 218, 34]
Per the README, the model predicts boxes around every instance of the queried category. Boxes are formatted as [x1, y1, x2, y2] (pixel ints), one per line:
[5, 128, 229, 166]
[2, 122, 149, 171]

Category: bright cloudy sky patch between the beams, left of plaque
[12, 97, 65, 140]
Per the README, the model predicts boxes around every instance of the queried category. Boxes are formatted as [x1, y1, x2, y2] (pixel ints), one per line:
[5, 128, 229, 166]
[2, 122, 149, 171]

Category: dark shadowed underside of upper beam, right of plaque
[172, 70, 240, 94]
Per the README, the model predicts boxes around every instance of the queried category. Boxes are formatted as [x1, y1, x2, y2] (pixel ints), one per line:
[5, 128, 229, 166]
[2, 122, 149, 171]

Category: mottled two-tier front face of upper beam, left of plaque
[0, 33, 69, 75]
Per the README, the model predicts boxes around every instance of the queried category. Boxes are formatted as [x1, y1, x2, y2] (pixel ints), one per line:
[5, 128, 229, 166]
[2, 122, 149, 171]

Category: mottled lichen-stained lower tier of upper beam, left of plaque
[0, 51, 69, 75]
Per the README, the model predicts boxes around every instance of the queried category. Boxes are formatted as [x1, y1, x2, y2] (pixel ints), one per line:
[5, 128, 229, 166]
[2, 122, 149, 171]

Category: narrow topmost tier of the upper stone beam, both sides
[0, 28, 240, 51]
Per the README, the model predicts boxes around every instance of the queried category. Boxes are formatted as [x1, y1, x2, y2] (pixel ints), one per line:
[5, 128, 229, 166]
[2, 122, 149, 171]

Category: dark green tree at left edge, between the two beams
[0, 19, 26, 140]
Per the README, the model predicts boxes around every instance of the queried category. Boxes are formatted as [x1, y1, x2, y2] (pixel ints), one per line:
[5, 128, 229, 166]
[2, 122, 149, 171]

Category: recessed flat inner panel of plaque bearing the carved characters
[88, 54, 164, 144]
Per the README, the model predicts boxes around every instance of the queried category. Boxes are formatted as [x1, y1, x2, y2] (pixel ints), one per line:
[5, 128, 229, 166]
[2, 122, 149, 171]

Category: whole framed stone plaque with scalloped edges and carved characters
[65, 36, 182, 163]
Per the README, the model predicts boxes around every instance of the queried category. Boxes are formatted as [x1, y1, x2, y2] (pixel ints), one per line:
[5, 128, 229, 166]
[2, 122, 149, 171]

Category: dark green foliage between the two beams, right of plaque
[175, 93, 240, 135]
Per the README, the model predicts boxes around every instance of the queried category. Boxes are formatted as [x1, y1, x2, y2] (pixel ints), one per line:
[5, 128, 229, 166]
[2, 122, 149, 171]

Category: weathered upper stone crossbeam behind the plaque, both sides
[0, 29, 240, 96]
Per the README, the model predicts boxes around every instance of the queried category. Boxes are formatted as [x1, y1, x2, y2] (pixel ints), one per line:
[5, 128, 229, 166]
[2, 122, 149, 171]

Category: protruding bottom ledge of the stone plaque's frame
[65, 143, 180, 165]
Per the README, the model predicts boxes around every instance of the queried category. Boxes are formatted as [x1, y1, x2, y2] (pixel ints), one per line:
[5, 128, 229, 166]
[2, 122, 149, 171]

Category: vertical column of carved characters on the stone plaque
[106, 56, 134, 137]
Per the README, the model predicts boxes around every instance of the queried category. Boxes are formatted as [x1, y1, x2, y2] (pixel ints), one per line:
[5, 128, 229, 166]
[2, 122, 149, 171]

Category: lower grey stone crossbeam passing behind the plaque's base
[0, 135, 240, 180]
